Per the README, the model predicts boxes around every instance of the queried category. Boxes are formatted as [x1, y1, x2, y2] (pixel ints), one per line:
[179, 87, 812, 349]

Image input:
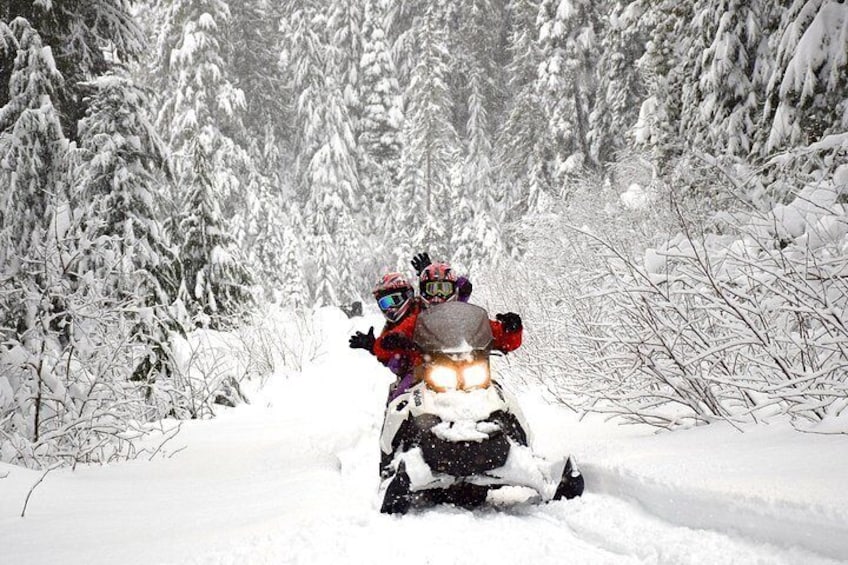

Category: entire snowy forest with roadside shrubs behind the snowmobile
[0, 0, 848, 468]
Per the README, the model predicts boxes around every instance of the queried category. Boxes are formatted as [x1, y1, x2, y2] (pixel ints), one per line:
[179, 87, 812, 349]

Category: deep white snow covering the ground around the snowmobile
[0, 310, 848, 565]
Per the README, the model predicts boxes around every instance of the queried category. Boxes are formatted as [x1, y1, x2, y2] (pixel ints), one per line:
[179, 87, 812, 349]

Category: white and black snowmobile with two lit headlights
[380, 302, 584, 514]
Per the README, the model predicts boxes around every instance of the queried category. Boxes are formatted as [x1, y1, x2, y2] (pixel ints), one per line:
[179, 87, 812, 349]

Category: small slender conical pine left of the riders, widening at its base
[179, 127, 253, 329]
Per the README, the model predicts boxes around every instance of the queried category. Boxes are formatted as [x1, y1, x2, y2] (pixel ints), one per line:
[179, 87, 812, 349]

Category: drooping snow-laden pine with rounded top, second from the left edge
[74, 75, 183, 400]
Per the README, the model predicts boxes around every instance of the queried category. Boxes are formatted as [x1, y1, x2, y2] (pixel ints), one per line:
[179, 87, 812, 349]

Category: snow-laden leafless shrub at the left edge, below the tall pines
[0, 226, 154, 467]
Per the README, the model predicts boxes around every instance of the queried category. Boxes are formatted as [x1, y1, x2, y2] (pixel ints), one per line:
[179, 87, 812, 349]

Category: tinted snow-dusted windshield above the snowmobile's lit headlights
[413, 302, 493, 354]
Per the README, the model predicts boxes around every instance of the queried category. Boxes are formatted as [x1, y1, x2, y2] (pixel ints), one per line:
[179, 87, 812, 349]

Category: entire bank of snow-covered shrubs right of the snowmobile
[475, 156, 848, 427]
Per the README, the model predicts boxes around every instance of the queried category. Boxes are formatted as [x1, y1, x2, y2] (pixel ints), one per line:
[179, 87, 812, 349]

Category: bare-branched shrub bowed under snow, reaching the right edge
[594, 174, 848, 425]
